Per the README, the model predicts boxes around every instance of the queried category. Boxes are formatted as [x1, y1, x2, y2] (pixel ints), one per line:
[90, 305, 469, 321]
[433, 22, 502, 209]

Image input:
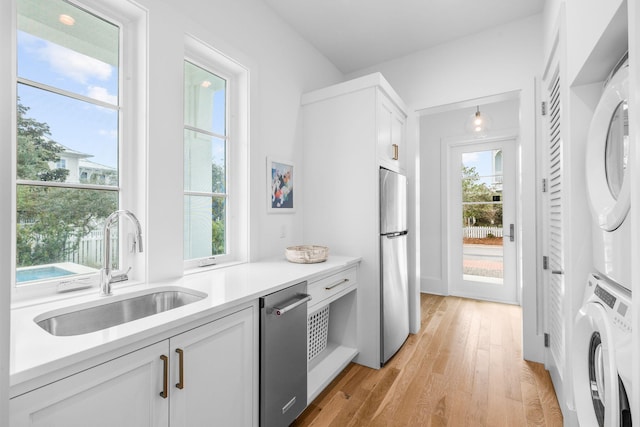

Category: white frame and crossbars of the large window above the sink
[11, 0, 147, 305]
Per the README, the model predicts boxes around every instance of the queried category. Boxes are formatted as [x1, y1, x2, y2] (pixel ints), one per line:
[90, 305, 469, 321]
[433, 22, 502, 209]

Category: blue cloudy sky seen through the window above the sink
[17, 31, 118, 168]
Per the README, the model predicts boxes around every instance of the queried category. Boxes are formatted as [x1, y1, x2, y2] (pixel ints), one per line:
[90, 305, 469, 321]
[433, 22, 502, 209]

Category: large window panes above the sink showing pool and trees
[16, 0, 142, 294]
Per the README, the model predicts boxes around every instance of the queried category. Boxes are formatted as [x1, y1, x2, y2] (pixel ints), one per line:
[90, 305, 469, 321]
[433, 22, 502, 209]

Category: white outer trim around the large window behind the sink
[11, 0, 148, 306]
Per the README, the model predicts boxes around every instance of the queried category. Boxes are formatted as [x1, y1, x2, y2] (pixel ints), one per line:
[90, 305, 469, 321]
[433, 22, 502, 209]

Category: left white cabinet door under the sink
[10, 341, 169, 427]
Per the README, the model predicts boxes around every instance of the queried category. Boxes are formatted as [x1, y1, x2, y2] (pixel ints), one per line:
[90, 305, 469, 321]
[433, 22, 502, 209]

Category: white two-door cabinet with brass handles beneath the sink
[10, 307, 257, 427]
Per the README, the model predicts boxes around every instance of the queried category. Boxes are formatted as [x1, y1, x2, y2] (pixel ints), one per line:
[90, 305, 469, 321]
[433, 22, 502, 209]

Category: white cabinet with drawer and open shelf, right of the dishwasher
[307, 267, 358, 403]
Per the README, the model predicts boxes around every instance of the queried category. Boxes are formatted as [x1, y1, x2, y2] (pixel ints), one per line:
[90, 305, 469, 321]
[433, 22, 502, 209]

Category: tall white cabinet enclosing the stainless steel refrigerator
[302, 73, 411, 368]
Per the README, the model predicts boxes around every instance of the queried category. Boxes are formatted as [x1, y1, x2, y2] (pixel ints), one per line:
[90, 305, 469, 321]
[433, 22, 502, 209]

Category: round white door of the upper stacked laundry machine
[586, 64, 630, 231]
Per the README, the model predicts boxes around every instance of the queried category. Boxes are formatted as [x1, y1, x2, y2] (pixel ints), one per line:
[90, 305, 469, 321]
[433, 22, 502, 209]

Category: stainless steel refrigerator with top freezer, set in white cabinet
[380, 168, 409, 365]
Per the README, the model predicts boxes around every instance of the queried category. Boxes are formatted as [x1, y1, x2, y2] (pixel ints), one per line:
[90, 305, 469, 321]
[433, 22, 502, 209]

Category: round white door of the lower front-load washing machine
[573, 302, 622, 427]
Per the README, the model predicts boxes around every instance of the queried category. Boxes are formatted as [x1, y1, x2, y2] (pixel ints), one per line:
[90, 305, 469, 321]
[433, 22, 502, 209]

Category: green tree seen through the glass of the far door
[462, 165, 502, 227]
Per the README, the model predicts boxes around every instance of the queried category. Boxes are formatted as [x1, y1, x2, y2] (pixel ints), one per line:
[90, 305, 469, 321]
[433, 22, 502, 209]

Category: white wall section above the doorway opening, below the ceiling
[348, 15, 542, 110]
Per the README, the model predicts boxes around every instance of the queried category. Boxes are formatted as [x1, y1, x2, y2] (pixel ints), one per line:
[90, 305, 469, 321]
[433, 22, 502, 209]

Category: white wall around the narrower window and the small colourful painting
[131, 0, 342, 280]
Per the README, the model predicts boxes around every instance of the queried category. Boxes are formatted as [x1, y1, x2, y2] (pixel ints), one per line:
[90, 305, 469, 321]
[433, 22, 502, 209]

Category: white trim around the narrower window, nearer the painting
[183, 34, 249, 274]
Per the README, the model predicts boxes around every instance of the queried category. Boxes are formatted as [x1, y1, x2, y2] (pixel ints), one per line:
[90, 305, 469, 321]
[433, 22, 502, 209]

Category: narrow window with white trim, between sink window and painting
[183, 37, 248, 268]
